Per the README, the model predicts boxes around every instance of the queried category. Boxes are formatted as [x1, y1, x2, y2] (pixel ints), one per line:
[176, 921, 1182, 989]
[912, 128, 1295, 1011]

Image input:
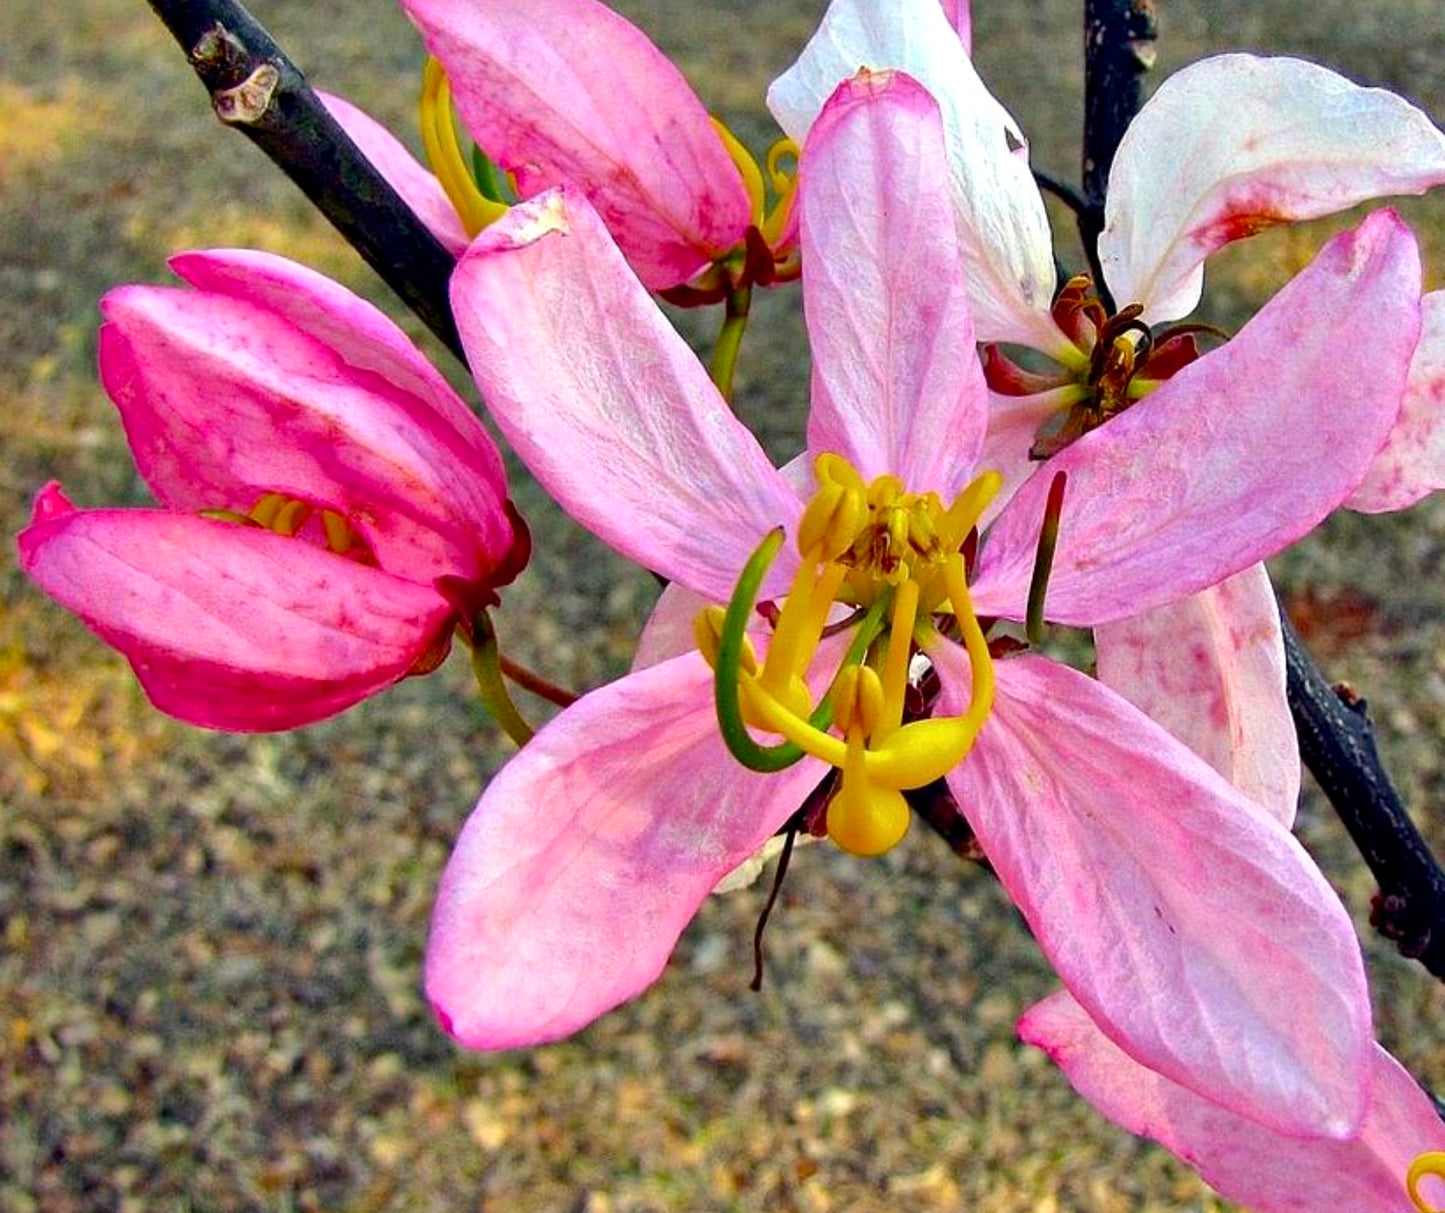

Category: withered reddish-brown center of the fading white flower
[984, 275, 1224, 460]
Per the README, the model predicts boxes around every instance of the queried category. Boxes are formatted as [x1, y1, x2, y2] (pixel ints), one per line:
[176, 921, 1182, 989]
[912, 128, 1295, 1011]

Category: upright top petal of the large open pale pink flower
[799, 72, 988, 497]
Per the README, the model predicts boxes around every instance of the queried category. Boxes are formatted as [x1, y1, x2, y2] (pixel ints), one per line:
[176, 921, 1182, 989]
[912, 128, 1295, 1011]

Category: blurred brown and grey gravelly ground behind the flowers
[0, 0, 1445, 1213]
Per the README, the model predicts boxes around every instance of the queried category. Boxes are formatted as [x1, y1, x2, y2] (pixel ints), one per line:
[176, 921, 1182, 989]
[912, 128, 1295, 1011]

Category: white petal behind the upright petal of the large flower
[767, 0, 1064, 350]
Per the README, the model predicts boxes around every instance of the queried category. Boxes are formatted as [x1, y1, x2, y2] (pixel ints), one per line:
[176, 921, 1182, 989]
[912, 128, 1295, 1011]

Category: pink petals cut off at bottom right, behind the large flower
[1019, 990, 1445, 1213]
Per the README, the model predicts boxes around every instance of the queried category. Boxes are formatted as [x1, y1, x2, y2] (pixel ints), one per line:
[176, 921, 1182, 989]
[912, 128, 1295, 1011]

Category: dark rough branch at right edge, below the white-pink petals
[1280, 610, 1445, 980]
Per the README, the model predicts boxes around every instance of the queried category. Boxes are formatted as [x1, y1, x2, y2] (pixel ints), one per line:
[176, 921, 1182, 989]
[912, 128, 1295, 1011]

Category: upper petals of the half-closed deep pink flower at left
[100, 252, 512, 583]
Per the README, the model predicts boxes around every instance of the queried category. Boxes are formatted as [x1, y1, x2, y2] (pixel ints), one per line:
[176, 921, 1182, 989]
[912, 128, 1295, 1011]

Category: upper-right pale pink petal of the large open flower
[975, 211, 1420, 627]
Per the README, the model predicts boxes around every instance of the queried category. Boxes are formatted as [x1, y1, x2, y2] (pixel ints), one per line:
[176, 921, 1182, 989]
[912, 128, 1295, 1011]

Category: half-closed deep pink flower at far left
[19, 250, 526, 730]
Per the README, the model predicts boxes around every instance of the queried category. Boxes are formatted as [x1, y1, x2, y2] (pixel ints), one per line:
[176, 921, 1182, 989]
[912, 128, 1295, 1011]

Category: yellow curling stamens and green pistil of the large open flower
[695, 454, 998, 854]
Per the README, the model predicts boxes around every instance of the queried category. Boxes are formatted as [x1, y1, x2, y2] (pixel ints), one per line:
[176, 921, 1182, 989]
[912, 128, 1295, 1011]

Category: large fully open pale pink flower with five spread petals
[426, 74, 1419, 1135]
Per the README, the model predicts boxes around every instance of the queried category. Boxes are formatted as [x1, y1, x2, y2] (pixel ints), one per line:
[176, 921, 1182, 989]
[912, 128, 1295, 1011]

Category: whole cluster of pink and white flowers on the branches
[20, 0, 1445, 1213]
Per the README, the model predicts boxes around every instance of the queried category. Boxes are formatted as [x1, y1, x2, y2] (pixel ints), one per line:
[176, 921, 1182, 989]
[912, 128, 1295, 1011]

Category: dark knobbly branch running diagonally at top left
[149, 0, 462, 357]
